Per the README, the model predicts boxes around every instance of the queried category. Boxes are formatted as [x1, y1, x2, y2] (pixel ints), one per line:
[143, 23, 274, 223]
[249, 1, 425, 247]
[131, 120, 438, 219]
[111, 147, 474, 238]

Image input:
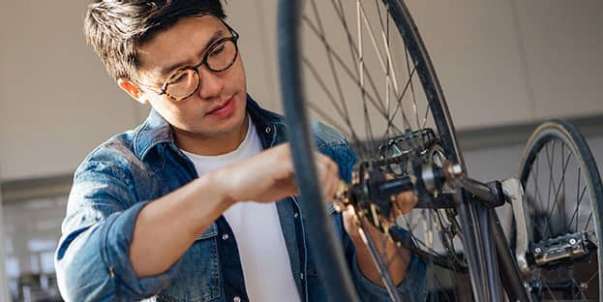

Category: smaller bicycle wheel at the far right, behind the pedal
[513, 121, 603, 301]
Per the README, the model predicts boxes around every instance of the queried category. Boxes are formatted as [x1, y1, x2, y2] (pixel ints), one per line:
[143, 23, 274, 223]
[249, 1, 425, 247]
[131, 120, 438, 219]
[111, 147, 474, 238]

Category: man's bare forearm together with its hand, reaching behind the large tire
[129, 145, 339, 277]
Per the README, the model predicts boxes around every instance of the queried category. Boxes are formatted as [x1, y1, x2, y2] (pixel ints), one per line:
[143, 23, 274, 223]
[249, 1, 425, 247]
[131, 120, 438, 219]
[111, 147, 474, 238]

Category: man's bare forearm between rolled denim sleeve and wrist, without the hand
[129, 174, 232, 277]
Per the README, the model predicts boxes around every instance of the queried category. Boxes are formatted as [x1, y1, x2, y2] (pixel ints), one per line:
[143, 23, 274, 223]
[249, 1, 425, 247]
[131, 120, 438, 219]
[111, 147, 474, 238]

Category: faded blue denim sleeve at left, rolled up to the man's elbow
[55, 152, 179, 301]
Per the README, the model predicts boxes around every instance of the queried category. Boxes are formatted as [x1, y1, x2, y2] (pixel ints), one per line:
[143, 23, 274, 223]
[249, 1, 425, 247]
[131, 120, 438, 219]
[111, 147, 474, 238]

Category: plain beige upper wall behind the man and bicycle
[0, 0, 603, 179]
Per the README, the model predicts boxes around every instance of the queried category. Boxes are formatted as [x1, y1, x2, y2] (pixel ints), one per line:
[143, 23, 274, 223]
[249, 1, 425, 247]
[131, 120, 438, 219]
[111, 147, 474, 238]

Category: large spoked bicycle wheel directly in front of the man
[278, 0, 496, 301]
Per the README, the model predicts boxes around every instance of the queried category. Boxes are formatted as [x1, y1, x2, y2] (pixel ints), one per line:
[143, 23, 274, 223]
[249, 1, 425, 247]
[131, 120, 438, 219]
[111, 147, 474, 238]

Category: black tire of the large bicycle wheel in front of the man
[278, 0, 496, 301]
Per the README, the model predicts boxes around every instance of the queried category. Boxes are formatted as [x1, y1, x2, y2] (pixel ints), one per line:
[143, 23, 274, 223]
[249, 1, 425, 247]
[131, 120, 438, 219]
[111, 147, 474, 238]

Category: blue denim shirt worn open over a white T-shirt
[55, 97, 426, 302]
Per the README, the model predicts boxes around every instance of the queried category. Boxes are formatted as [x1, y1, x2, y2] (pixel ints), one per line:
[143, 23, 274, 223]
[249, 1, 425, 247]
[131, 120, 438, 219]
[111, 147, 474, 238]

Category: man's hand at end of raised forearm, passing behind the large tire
[212, 144, 339, 203]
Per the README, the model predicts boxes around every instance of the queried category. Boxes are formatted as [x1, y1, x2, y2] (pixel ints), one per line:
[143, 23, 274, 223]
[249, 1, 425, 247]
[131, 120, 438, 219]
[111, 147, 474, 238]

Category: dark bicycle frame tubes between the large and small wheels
[408, 162, 529, 301]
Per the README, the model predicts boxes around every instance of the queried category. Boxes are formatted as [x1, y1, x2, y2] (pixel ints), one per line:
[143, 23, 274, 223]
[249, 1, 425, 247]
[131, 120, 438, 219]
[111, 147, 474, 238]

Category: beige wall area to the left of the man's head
[0, 0, 137, 179]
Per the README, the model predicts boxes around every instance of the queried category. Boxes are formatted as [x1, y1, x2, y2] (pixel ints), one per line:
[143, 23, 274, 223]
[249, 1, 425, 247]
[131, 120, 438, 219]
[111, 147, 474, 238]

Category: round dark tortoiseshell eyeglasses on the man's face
[143, 23, 239, 102]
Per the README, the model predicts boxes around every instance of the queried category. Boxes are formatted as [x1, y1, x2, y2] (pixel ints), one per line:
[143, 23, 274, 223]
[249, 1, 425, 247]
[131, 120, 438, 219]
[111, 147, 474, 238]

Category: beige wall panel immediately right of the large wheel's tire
[407, 0, 532, 128]
